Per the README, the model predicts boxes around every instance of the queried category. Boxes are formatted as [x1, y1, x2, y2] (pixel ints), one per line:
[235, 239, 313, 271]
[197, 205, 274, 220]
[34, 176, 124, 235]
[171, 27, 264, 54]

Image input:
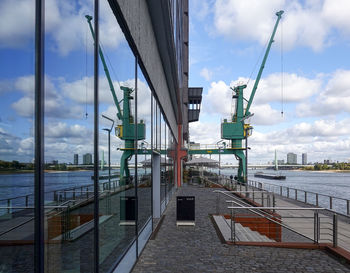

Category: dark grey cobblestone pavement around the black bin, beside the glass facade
[133, 186, 350, 273]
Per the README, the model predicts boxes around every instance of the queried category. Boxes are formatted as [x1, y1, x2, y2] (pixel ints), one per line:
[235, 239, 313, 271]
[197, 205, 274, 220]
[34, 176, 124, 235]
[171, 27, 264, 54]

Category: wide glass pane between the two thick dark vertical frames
[44, 0, 94, 272]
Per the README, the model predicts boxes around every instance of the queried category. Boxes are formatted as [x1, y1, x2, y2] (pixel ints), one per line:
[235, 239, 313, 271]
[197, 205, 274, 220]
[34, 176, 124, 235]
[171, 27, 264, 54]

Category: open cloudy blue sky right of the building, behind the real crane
[189, 0, 350, 164]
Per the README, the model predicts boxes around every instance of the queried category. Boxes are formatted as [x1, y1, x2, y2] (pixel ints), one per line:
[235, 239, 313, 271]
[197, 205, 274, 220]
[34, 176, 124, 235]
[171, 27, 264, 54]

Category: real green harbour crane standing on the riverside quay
[221, 10, 283, 182]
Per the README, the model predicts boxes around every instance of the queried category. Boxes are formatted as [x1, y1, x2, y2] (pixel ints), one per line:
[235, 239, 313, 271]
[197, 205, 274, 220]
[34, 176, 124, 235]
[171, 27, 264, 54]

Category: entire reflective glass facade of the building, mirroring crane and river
[0, 0, 179, 272]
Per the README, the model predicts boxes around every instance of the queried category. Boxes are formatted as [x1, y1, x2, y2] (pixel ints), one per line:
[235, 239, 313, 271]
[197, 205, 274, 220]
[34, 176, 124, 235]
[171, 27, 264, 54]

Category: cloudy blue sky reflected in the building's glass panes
[0, 0, 151, 164]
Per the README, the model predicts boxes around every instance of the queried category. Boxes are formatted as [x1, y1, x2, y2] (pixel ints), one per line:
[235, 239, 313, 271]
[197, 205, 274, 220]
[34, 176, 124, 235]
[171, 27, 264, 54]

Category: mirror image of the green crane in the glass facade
[85, 15, 146, 184]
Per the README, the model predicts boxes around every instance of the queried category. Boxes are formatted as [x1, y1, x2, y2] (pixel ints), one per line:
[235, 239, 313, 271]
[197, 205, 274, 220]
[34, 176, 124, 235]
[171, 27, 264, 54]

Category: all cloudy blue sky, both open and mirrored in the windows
[0, 0, 350, 166]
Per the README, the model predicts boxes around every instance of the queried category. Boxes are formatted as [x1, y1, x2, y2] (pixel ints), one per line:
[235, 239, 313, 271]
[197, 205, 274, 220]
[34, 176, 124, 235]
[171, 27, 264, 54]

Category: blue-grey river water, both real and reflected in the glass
[0, 169, 350, 213]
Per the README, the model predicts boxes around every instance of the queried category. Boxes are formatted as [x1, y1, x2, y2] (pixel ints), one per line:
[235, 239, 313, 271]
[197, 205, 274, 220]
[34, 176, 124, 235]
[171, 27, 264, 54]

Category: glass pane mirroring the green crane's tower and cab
[98, 1, 137, 272]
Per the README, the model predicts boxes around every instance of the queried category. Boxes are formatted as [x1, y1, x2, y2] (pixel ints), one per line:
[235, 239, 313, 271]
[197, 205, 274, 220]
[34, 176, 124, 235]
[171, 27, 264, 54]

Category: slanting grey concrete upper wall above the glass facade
[109, 0, 181, 140]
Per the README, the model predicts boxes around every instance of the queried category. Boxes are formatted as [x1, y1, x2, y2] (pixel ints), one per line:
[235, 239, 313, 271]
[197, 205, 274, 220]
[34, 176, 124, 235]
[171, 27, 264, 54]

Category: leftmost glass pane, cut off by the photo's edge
[0, 0, 35, 272]
